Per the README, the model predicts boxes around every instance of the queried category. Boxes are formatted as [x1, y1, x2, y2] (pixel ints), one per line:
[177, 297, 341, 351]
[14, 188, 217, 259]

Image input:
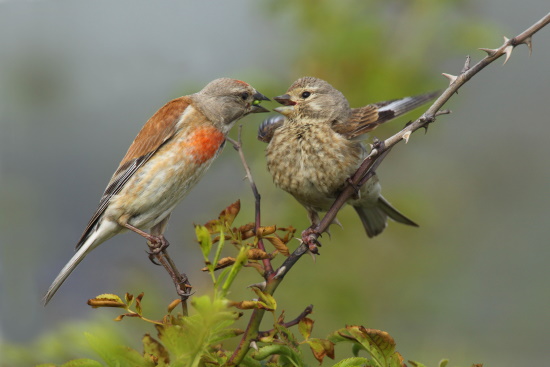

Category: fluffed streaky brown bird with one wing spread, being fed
[258, 77, 438, 238]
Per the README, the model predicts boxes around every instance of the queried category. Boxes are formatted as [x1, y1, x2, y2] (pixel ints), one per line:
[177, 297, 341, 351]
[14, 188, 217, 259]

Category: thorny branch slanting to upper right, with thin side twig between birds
[226, 13, 550, 366]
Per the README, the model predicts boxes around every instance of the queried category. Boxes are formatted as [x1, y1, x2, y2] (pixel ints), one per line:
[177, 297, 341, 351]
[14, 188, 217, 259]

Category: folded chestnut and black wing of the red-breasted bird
[76, 97, 191, 250]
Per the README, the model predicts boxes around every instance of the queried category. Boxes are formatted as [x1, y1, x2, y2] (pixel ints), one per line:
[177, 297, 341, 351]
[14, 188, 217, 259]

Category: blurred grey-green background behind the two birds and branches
[0, 0, 550, 367]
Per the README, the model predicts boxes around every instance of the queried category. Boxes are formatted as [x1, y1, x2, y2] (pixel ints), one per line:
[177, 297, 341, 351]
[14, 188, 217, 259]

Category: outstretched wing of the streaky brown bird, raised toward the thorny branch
[332, 91, 440, 139]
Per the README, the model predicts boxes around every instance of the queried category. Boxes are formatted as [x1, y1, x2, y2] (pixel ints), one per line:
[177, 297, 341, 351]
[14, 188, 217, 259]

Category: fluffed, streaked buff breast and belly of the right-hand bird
[266, 123, 364, 210]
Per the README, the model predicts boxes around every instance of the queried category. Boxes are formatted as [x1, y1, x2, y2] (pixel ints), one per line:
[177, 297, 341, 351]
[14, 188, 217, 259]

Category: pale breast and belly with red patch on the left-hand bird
[106, 125, 225, 229]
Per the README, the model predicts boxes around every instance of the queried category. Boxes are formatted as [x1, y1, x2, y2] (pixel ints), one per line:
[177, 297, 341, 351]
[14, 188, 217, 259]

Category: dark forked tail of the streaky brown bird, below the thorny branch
[353, 196, 418, 238]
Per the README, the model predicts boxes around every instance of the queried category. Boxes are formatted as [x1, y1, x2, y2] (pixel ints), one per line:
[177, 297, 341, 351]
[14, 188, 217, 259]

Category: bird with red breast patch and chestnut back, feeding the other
[43, 78, 269, 305]
